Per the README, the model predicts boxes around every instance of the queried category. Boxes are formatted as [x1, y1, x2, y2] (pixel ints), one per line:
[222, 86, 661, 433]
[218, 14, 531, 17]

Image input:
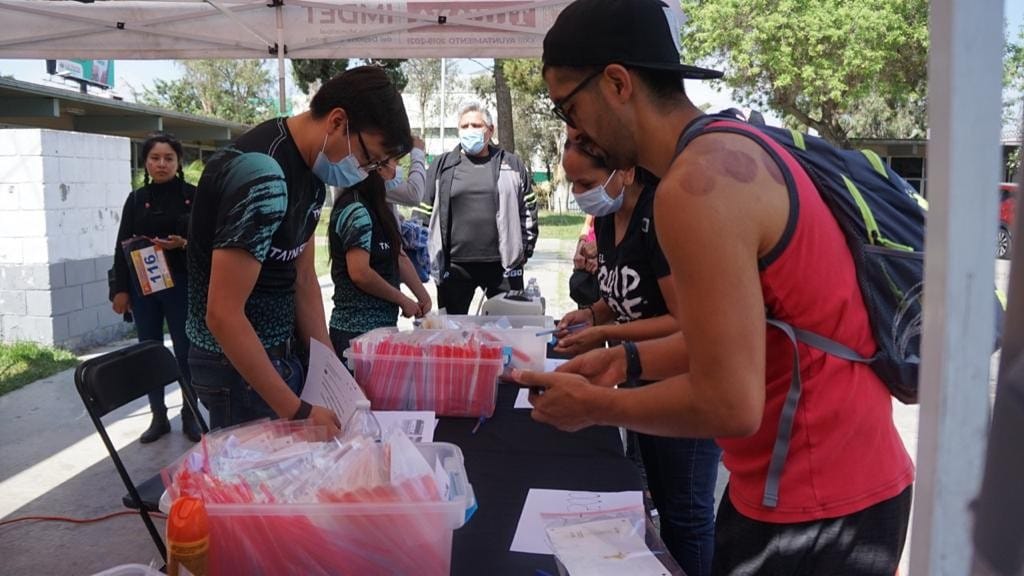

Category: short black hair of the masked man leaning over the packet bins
[309, 66, 413, 157]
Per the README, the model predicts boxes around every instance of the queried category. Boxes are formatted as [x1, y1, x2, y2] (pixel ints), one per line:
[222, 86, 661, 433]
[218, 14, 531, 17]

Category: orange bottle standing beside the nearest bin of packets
[167, 496, 210, 576]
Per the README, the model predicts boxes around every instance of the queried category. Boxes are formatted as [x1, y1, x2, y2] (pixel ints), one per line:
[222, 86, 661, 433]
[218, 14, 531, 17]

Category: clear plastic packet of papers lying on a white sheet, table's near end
[547, 518, 671, 576]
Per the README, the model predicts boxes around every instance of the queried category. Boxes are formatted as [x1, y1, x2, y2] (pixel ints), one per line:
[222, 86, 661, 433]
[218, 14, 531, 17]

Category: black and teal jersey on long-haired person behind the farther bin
[330, 191, 399, 332]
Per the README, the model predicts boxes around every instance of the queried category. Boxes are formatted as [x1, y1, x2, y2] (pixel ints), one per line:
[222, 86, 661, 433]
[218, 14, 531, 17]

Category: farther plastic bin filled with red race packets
[346, 328, 506, 417]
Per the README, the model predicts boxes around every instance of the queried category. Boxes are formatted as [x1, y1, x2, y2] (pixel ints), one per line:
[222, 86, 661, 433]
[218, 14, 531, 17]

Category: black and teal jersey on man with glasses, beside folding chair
[186, 118, 326, 352]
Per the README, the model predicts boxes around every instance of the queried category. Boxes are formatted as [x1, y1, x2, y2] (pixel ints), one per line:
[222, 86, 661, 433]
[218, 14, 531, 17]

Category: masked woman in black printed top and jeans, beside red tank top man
[555, 138, 721, 576]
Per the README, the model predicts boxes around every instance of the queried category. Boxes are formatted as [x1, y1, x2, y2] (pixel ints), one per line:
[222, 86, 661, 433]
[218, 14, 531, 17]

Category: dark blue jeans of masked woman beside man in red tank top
[637, 434, 722, 576]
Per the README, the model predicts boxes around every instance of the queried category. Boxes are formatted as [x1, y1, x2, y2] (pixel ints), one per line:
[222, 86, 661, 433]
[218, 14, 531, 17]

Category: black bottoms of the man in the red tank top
[712, 487, 912, 576]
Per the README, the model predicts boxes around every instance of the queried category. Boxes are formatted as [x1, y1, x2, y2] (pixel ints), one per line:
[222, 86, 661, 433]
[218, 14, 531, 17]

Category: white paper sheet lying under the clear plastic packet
[510, 488, 643, 554]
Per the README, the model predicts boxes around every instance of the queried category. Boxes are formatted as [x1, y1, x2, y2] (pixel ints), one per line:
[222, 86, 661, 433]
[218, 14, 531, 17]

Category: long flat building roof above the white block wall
[0, 78, 249, 148]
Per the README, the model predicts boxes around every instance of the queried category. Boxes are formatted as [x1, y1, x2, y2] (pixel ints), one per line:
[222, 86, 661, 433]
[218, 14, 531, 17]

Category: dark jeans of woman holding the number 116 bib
[129, 274, 191, 414]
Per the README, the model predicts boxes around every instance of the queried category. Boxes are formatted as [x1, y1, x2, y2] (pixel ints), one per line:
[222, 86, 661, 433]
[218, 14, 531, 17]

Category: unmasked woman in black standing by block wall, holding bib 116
[113, 134, 200, 444]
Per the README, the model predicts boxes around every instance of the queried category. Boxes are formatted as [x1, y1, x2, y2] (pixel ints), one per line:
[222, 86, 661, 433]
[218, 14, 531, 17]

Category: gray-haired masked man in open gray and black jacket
[419, 101, 538, 314]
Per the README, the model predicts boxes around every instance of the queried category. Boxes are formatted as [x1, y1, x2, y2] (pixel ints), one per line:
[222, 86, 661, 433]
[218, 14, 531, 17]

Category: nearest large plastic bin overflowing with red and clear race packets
[163, 420, 475, 575]
